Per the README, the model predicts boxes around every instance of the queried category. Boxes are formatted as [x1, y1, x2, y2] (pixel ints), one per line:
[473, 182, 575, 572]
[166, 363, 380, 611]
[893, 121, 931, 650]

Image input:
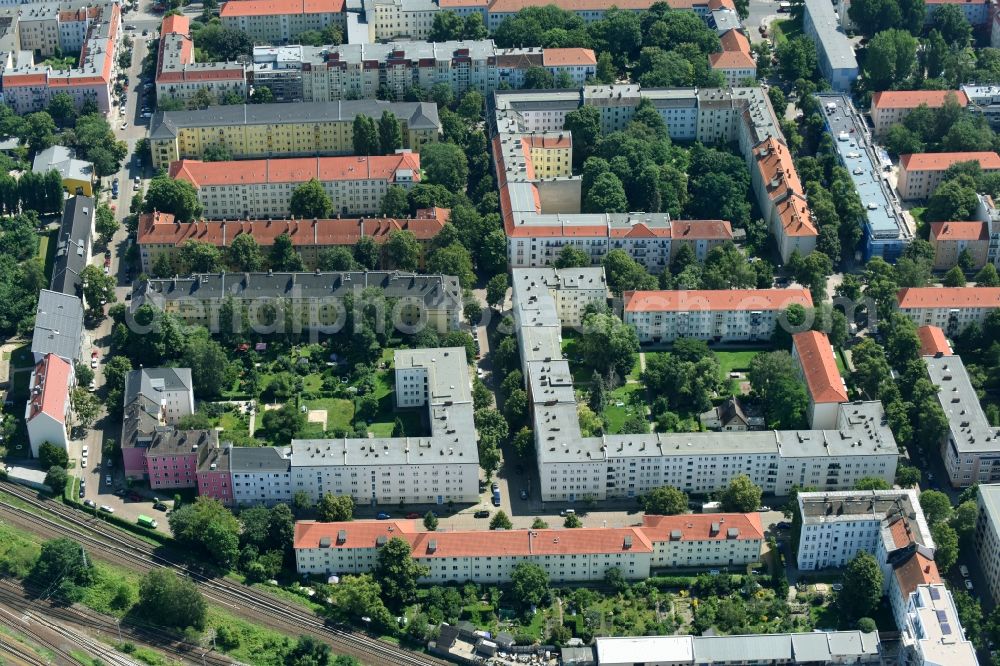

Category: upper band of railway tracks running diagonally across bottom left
[0, 482, 448, 666]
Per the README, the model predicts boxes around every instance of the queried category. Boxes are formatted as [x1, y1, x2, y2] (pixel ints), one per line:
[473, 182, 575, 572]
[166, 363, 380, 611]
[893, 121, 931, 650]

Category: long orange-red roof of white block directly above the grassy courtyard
[622, 289, 812, 312]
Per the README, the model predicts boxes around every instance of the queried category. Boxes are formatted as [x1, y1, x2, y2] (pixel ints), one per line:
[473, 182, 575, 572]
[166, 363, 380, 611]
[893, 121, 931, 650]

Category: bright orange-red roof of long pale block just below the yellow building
[170, 153, 420, 188]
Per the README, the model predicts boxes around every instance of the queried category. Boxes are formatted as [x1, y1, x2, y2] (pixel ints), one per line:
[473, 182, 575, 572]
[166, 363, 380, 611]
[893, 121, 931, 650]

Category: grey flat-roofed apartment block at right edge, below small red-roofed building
[923, 354, 1000, 488]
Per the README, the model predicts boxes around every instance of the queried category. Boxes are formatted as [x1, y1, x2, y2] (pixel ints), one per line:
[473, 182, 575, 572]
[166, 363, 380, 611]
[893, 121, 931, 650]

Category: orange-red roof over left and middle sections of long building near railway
[294, 520, 653, 558]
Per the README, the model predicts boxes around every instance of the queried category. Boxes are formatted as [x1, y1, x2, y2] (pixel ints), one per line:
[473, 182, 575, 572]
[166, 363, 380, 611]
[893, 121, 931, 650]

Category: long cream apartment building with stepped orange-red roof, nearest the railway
[294, 514, 764, 584]
